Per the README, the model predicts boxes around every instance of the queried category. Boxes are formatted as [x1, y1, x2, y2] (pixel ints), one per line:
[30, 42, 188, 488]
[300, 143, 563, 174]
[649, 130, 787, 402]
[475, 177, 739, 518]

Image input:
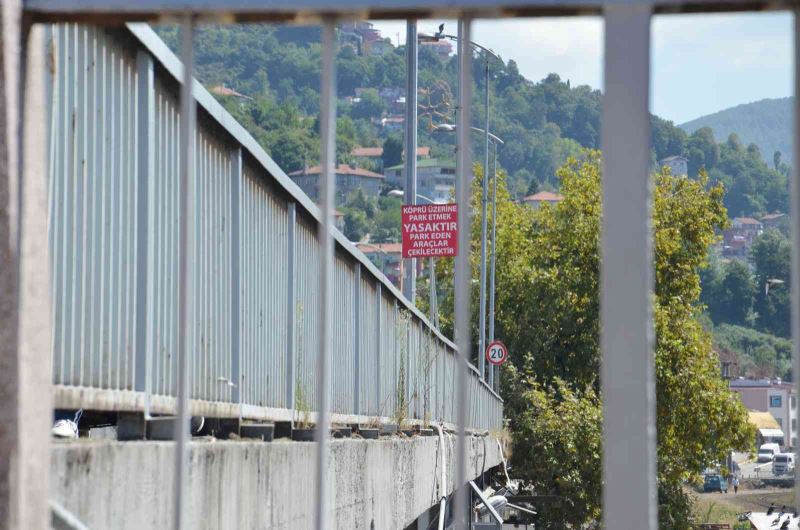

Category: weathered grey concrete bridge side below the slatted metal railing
[51, 436, 500, 530]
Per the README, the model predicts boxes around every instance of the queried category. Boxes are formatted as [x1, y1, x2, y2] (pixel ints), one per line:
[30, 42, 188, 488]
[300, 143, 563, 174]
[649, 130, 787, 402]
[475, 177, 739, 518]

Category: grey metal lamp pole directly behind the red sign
[403, 19, 418, 304]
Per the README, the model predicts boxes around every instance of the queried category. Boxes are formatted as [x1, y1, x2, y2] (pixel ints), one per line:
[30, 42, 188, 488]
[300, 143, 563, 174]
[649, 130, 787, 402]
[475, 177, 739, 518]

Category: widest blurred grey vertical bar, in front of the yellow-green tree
[600, 5, 657, 530]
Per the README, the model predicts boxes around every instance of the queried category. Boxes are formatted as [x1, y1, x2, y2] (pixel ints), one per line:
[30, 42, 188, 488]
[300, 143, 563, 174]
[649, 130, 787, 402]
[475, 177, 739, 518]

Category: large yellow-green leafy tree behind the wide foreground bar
[437, 151, 753, 529]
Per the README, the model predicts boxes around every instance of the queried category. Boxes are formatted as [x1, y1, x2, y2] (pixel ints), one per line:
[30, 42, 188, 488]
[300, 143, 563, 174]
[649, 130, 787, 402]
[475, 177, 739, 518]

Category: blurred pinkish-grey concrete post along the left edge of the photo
[0, 16, 52, 530]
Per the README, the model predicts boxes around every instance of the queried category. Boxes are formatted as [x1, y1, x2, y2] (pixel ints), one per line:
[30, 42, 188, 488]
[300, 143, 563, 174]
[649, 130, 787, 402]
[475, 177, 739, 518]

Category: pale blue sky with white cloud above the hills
[374, 12, 793, 124]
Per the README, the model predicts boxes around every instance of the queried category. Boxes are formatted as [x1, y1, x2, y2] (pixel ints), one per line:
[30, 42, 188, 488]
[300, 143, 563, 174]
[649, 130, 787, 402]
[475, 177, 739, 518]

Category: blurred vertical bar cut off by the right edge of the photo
[789, 10, 800, 506]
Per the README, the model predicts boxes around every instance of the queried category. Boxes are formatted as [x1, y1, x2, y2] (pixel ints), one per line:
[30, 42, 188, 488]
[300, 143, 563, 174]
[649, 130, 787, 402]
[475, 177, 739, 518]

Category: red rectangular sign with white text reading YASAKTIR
[403, 204, 458, 258]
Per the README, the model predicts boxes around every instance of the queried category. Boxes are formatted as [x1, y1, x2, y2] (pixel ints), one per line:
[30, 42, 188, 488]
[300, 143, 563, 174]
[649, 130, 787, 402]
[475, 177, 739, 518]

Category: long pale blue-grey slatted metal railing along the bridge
[48, 24, 502, 429]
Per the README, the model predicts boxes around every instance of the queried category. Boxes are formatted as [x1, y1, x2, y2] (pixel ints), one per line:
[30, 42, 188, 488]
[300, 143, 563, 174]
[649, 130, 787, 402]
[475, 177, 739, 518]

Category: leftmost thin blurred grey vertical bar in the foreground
[174, 13, 196, 530]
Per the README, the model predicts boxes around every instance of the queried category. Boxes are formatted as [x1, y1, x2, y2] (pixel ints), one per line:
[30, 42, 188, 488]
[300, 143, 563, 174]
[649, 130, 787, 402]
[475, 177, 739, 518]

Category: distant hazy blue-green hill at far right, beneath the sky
[679, 98, 794, 164]
